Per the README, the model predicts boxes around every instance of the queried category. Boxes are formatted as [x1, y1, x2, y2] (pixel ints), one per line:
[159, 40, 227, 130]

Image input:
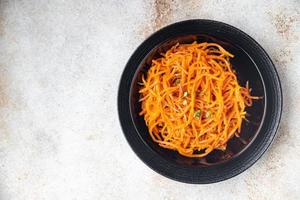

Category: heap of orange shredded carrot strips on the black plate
[139, 42, 259, 157]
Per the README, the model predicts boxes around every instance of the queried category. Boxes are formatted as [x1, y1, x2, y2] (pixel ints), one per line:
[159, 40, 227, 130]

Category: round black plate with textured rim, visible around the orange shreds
[118, 20, 282, 183]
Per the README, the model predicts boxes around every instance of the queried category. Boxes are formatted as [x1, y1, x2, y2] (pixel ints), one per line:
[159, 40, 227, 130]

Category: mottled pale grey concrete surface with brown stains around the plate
[0, 0, 300, 200]
